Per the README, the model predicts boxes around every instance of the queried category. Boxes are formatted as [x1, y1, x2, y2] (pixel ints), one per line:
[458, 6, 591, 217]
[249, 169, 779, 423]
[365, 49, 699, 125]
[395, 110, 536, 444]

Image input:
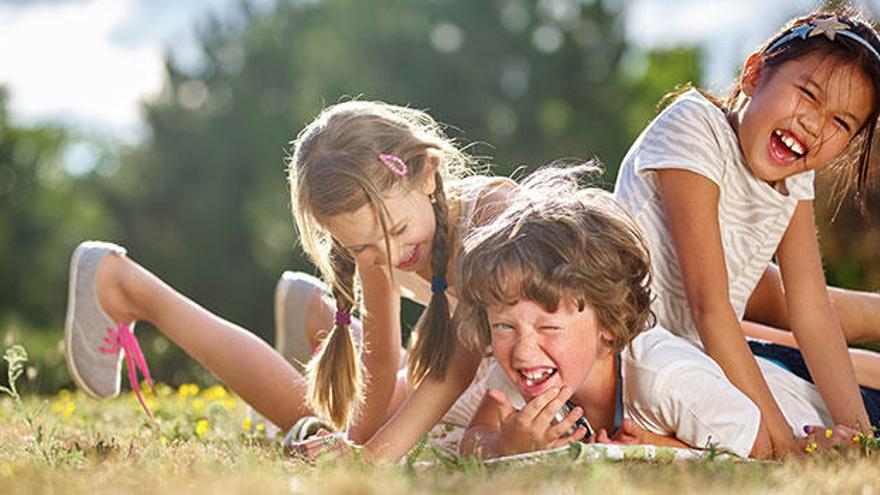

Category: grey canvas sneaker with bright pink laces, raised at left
[64, 241, 134, 399]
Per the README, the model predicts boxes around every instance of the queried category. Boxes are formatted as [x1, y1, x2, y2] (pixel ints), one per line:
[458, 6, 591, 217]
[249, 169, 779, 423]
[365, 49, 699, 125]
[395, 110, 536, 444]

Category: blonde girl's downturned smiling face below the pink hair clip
[324, 179, 435, 272]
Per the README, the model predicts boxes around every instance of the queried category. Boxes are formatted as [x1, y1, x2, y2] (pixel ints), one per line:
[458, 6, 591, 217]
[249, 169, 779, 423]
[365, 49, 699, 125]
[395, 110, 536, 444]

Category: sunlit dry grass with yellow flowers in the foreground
[0, 346, 880, 495]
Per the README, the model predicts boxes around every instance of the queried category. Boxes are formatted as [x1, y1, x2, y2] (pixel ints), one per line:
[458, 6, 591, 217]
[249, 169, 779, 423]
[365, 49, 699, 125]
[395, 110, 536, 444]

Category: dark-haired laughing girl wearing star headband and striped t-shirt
[615, 9, 880, 455]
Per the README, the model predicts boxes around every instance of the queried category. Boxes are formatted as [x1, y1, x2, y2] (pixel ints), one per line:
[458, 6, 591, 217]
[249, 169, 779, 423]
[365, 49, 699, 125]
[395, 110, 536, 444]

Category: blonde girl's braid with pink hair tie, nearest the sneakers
[307, 241, 365, 430]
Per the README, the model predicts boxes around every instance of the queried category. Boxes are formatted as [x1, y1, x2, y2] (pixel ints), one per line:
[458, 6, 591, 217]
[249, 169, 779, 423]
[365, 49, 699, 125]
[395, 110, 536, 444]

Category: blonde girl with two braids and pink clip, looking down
[65, 101, 512, 460]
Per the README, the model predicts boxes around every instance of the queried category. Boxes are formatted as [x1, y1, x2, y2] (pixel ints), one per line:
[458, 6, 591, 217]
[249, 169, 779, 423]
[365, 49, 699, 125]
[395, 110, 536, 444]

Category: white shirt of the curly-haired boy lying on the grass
[487, 327, 831, 457]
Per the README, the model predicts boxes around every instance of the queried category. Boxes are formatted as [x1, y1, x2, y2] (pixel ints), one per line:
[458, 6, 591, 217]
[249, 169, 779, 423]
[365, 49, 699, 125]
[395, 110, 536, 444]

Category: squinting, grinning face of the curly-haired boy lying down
[486, 297, 612, 401]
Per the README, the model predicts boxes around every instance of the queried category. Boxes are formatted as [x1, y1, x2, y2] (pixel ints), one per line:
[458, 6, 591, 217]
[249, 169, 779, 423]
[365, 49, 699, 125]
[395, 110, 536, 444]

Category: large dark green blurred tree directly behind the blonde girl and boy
[114, 0, 696, 344]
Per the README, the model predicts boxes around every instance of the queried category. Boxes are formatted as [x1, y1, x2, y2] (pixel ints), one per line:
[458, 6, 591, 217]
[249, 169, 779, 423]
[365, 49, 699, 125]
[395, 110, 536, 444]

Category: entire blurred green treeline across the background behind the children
[0, 0, 699, 387]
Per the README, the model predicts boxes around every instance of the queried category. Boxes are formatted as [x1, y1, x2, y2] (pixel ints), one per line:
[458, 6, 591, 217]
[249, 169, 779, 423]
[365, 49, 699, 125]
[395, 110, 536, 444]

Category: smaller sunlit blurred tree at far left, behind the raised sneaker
[0, 87, 115, 331]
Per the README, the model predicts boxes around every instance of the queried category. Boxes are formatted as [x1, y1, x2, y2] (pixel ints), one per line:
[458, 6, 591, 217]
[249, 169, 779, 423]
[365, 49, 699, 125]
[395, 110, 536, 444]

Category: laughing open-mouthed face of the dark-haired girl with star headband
[736, 53, 875, 184]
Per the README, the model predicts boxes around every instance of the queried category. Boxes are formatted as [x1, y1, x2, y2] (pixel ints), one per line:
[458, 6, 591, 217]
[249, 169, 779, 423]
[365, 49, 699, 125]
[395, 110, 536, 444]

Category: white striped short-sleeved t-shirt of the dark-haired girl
[614, 90, 814, 345]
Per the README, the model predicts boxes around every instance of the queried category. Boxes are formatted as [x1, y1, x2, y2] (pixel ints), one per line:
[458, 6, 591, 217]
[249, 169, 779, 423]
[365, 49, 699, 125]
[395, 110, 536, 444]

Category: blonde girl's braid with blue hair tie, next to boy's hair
[407, 172, 455, 387]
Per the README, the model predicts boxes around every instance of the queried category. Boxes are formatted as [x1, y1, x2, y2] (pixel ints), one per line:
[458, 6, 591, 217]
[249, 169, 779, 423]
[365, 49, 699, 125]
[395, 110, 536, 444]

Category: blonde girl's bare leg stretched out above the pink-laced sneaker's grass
[95, 254, 310, 429]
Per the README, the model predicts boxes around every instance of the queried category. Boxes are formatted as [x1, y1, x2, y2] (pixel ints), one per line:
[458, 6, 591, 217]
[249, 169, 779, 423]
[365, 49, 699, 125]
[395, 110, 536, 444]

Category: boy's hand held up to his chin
[489, 387, 586, 455]
